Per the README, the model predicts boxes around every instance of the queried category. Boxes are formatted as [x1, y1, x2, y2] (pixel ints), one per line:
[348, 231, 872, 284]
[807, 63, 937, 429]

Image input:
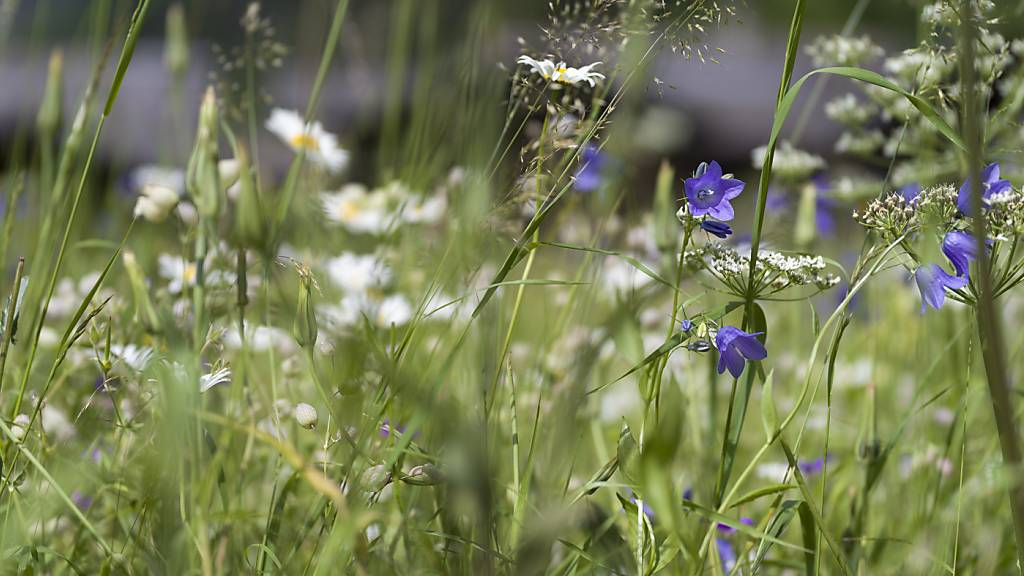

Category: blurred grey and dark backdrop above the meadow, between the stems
[0, 0, 999, 181]
